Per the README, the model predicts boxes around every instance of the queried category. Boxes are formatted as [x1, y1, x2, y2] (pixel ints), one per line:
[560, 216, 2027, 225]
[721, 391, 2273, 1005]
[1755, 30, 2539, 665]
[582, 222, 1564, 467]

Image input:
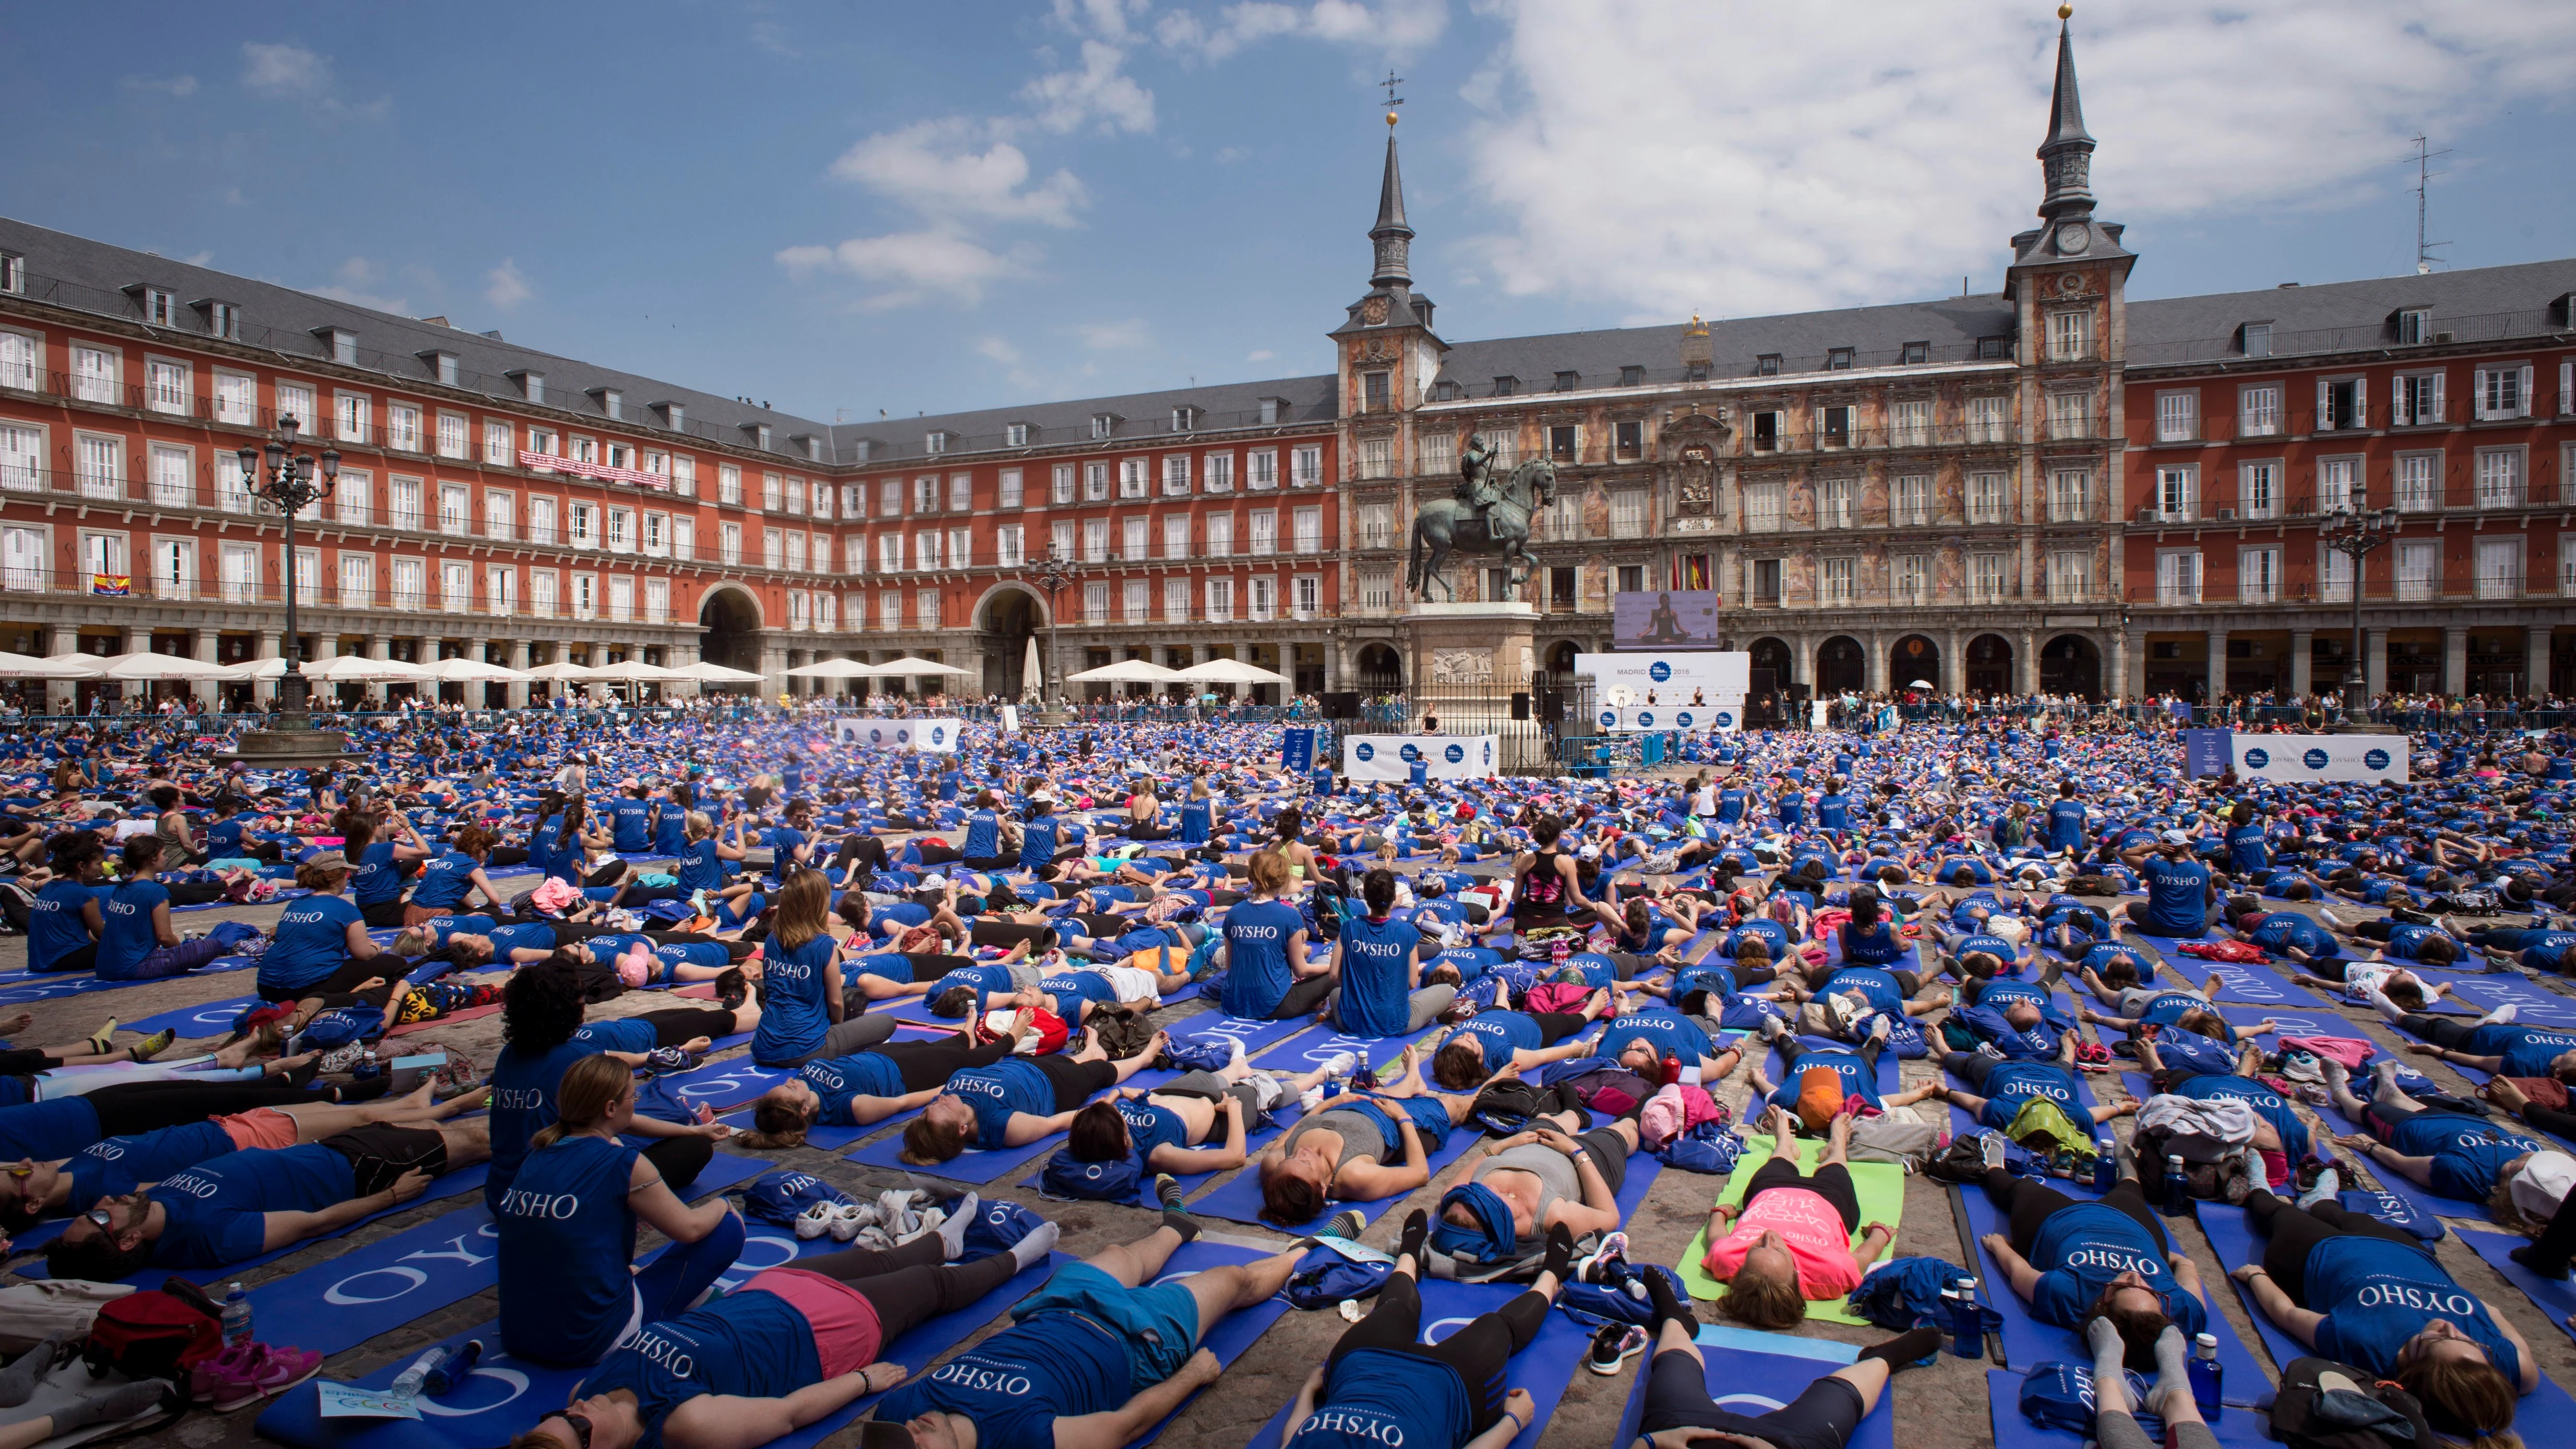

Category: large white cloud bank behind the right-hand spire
[1463, 0, 2576, 317]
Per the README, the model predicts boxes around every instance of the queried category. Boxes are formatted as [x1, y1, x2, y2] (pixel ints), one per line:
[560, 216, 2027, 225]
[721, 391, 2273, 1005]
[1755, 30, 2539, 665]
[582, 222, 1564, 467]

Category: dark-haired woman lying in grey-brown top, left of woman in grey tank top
[1255, 1047, 1484, 1222]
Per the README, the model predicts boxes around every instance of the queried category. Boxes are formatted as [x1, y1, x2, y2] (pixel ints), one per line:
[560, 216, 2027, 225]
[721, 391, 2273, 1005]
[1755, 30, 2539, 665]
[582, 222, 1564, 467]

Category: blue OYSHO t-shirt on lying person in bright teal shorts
[876, 1313, 1128, 1449]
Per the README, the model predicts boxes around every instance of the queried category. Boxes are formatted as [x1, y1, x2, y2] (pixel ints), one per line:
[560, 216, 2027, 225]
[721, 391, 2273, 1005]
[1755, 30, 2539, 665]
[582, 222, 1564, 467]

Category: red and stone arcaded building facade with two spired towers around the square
[0, 11, 2576, 704]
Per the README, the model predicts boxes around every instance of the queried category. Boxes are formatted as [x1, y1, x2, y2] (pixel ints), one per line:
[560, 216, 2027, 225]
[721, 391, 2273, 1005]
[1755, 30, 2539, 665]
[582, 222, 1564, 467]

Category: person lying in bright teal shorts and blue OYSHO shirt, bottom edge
[860, 1212, 1304, 1449]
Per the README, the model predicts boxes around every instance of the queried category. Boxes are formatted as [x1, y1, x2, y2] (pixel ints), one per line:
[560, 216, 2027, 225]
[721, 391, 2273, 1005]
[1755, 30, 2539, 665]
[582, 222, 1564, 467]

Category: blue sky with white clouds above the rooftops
[0, 0, 2576, 423]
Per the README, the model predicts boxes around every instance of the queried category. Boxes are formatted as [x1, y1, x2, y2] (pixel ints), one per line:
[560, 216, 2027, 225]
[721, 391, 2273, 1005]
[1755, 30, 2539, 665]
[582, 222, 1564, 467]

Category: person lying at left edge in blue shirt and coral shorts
[0, 1083, 477, 1235]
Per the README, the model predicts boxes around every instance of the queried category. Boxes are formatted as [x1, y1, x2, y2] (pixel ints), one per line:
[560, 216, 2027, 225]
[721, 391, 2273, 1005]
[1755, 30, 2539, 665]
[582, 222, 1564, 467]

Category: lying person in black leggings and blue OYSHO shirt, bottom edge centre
[1283, 1206, 1576, 1449]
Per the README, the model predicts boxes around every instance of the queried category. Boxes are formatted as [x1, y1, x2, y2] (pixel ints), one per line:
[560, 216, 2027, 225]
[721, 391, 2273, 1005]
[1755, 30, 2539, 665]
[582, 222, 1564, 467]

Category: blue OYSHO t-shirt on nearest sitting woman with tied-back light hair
[492, 1132, 641, 1364]
